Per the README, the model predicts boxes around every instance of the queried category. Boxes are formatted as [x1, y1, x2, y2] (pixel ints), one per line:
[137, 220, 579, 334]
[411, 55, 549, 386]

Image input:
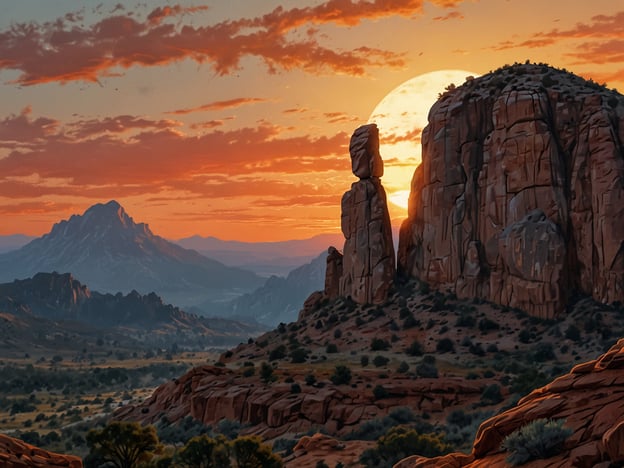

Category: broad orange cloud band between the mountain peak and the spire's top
[0, 113, 349, 197]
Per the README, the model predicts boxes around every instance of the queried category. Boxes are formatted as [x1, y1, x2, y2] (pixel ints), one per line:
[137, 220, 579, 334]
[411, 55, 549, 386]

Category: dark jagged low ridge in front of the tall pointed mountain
[0, 273, 262, 349]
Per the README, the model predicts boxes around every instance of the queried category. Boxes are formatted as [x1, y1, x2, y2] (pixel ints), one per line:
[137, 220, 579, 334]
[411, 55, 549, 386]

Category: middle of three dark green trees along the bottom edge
[175, 434, 231, 468]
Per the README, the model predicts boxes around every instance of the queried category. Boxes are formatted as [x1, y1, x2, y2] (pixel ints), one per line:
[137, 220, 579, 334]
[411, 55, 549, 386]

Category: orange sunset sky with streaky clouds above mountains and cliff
[0, 0, 624, 241]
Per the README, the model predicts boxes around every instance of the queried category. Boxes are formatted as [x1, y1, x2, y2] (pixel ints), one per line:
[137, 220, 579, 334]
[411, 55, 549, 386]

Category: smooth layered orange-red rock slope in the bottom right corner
[397, 339, 624, 468]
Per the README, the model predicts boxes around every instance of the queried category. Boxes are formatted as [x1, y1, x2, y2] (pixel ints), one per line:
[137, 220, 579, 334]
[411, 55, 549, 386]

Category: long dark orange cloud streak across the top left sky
[0, 0, 463, 85]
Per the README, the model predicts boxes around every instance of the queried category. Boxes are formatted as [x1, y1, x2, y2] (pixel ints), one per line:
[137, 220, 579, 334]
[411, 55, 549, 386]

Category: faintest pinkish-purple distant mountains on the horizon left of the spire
[175, 233, 344, 276]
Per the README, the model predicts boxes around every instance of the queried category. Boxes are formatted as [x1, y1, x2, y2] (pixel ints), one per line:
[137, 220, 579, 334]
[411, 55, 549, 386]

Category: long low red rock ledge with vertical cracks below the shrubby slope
[115, 366, 491, 439]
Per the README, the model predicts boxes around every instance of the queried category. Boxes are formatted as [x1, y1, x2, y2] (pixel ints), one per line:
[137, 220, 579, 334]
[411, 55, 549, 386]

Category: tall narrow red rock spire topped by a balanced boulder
[325, 124, 395, 304]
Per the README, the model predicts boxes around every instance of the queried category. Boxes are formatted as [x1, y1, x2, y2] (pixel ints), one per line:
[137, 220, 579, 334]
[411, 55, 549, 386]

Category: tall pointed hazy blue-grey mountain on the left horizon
[0, 201, 264, 305]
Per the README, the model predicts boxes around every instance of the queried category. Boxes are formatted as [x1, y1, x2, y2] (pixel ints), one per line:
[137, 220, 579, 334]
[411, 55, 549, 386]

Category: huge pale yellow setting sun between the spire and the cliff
[368, 70, 476, 212]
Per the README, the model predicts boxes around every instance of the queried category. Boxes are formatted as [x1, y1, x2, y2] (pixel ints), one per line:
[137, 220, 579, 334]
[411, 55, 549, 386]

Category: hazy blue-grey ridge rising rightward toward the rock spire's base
[206, 252, 327, 326]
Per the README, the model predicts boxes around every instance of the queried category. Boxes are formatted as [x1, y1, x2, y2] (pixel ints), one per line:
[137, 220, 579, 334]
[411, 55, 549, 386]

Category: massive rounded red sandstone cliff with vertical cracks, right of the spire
[398, 65, 624, 318]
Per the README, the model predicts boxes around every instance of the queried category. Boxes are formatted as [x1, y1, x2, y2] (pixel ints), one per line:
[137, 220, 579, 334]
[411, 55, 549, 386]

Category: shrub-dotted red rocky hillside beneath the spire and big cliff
[117, 283, 624, 445]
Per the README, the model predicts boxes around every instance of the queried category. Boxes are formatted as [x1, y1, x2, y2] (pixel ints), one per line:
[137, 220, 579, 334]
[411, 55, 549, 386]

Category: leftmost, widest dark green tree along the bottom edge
[85, 421, 160, 468]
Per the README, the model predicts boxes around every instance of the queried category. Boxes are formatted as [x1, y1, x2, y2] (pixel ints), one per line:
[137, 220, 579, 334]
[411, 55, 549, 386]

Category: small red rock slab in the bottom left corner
[0, 434, 82, 468]
